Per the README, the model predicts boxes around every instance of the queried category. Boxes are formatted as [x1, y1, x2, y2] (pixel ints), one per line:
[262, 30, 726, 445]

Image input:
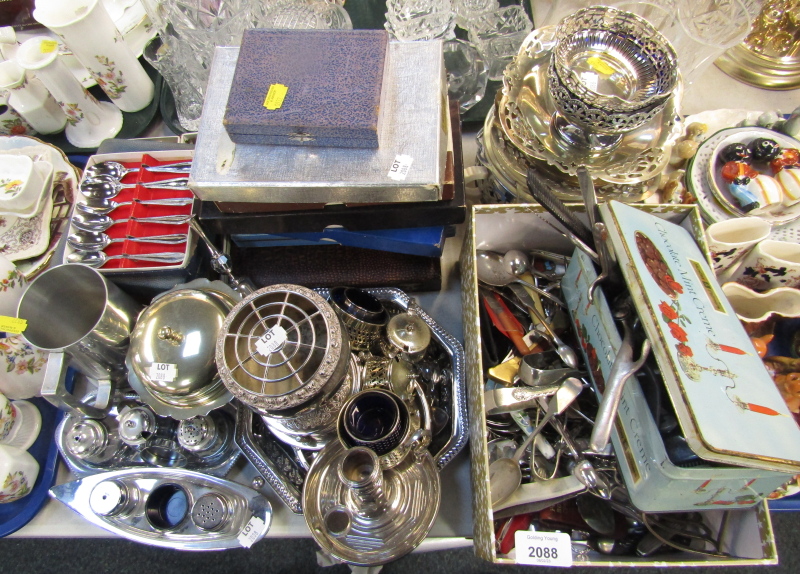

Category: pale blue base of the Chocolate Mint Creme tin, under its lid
[561, 248, 790, 512]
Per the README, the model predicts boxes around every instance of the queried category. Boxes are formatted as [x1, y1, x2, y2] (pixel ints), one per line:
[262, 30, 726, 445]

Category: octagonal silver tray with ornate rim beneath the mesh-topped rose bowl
[235, 287, 469, 514]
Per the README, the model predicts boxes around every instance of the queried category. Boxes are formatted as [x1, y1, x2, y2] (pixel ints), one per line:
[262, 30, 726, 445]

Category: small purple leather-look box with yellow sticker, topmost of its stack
[223, 29, 389, 148]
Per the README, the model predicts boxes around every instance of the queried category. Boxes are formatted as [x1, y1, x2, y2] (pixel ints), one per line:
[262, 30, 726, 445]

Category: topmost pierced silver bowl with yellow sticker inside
[553, 6, 678, 114]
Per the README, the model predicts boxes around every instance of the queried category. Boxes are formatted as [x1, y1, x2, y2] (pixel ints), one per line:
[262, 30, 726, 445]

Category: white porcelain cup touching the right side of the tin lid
[706, 217, 772, 277]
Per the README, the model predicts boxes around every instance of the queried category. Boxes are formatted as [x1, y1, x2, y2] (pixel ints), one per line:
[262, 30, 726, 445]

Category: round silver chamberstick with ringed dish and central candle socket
[303, 442, 441, 566]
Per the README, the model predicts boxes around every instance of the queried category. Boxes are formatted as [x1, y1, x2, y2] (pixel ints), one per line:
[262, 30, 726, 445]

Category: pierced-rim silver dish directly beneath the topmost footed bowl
[498, 26, 681, 184]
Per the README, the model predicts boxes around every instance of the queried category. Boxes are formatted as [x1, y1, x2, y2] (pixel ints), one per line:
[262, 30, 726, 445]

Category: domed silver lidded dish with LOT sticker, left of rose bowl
[125, 280, 237, 420]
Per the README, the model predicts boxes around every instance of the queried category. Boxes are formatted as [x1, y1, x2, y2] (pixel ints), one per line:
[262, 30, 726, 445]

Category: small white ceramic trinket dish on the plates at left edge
[0, 155, 53, 217]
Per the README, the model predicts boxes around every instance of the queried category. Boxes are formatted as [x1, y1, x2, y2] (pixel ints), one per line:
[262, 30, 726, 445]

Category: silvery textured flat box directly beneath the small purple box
[189, 40, 451, 204]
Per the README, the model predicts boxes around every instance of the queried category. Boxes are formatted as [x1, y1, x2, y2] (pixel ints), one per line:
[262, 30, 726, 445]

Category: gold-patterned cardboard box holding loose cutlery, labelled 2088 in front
[461, 204, 778, 566]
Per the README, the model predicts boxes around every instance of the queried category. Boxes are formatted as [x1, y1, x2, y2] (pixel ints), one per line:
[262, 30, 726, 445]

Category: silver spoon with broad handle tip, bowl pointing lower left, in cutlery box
[489, 377, 583, 507]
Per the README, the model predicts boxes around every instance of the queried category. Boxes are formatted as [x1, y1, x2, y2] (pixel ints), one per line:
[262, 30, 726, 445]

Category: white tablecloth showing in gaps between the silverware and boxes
[11, 57, 800, 551]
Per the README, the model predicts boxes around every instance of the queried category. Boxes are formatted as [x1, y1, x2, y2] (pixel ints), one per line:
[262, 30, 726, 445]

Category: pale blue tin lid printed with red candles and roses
[601, 201, 800, 473]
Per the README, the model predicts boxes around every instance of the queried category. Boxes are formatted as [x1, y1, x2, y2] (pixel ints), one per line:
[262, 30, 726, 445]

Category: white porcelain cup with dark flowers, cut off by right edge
[731, 239, 800, 291]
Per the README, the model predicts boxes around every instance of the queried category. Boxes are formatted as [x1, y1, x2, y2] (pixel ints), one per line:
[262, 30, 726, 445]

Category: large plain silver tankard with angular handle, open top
[17, 264, 142, 418]
